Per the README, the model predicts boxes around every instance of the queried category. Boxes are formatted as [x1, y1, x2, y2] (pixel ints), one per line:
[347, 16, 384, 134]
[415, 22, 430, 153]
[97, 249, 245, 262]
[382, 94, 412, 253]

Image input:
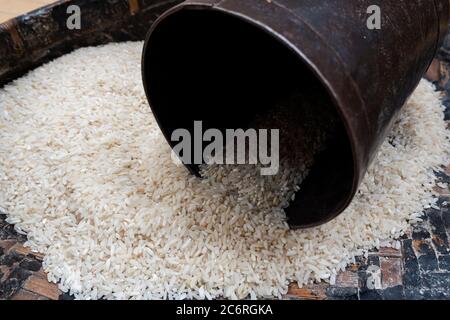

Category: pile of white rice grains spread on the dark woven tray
[0, 42, 449, 299]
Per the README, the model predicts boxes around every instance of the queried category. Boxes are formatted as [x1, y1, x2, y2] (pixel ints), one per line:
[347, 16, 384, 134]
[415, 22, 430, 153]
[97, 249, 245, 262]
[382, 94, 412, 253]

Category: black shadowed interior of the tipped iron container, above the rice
[143, 9, 354, 227]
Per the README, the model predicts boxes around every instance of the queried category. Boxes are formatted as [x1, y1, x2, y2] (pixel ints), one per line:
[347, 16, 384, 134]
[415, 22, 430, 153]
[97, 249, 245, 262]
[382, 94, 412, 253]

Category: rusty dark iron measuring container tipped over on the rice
[142, 0, 449, 228]
